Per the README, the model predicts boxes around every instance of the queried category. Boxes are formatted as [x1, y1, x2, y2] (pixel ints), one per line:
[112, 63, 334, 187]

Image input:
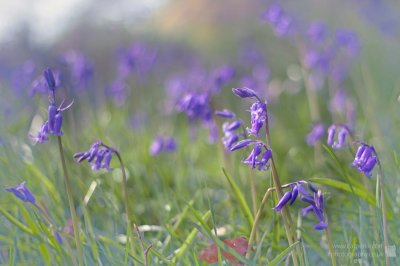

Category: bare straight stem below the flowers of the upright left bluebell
[57, 136, 84, 265]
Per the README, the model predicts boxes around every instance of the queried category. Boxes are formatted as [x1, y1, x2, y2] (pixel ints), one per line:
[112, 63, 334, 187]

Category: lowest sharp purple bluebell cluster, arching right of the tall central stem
[273, 181, 328, 230]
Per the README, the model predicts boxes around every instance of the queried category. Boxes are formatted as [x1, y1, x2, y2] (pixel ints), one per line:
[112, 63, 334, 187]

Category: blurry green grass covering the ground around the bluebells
[0, 1, 400, 265]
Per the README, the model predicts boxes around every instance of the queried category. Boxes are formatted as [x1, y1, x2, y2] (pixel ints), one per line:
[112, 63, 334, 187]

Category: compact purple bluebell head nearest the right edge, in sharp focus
[352, 143, 378, 177]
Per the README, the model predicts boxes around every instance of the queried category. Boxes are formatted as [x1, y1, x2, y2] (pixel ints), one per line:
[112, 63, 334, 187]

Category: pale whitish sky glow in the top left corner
[0, 0, 168, 43]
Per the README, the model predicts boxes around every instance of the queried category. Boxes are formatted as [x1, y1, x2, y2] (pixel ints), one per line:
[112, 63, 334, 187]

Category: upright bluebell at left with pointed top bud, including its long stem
[31, 68, 84, 265]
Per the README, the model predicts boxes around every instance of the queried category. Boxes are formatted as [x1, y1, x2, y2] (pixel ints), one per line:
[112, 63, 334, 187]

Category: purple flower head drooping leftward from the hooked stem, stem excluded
[74, 141, 116, 171]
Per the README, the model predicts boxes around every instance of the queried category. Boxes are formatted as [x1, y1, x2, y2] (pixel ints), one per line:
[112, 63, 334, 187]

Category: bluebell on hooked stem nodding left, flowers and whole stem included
[74, 141, 133, 263]
